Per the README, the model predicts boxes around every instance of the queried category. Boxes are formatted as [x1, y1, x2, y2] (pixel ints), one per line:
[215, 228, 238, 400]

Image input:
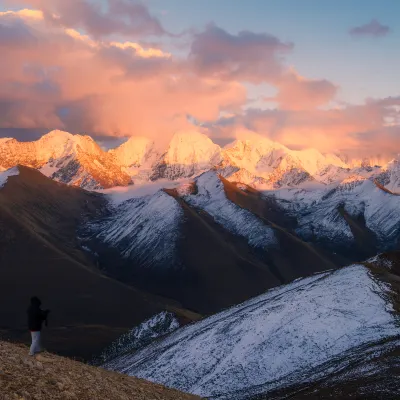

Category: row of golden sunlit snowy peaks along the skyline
[0, 131, 400, 193]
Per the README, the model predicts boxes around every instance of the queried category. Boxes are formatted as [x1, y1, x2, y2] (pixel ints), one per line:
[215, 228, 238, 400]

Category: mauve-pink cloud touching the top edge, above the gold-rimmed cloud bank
[2, 0, 167, 39]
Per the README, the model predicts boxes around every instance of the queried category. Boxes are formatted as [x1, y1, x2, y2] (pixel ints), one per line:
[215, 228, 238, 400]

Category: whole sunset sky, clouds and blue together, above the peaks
[0, 0, 400, 158]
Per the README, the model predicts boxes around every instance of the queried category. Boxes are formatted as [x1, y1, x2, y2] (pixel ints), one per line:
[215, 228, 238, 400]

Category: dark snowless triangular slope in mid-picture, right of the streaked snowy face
[165, 189, 282, 313]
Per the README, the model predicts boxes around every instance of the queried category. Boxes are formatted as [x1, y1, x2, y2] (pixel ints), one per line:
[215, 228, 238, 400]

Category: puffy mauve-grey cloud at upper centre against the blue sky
[189, 24, 293, 83]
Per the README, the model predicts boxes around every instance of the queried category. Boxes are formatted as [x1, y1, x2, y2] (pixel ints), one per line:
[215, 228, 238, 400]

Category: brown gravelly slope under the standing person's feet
[0, 342, 200, 400]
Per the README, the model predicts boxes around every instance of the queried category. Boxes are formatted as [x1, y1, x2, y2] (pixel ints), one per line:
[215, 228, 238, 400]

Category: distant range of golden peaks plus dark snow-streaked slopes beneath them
[0, 131, 400, 314]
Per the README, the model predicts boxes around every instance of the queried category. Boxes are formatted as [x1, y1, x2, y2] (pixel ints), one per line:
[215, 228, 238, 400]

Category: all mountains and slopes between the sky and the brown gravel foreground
[0, 131, 400, 400]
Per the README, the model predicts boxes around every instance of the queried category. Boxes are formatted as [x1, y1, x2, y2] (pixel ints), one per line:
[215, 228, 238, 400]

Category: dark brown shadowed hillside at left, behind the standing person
[0, 167, 197, 359]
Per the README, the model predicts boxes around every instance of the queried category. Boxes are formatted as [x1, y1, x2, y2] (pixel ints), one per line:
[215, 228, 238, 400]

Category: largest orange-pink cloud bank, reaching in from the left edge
[0, 10, 246, 144]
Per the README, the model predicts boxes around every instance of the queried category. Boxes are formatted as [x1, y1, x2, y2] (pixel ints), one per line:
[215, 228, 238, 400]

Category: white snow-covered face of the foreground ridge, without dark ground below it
[106, 265, 400, 400]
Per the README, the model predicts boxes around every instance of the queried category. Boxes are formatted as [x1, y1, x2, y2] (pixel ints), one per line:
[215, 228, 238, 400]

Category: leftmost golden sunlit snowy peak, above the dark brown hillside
[0, 131, 131, 189]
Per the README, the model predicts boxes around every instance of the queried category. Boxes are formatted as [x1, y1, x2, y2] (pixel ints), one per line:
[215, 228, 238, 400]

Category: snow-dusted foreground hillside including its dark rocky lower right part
[105, 253, 400, 400]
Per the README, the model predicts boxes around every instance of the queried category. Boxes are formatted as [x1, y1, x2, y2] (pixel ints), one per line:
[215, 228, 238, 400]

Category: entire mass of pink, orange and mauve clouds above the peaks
[0, 4, 400, 160]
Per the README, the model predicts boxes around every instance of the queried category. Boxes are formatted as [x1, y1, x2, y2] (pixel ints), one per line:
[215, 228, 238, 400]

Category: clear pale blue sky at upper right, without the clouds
[146, 0, 400, 103]
